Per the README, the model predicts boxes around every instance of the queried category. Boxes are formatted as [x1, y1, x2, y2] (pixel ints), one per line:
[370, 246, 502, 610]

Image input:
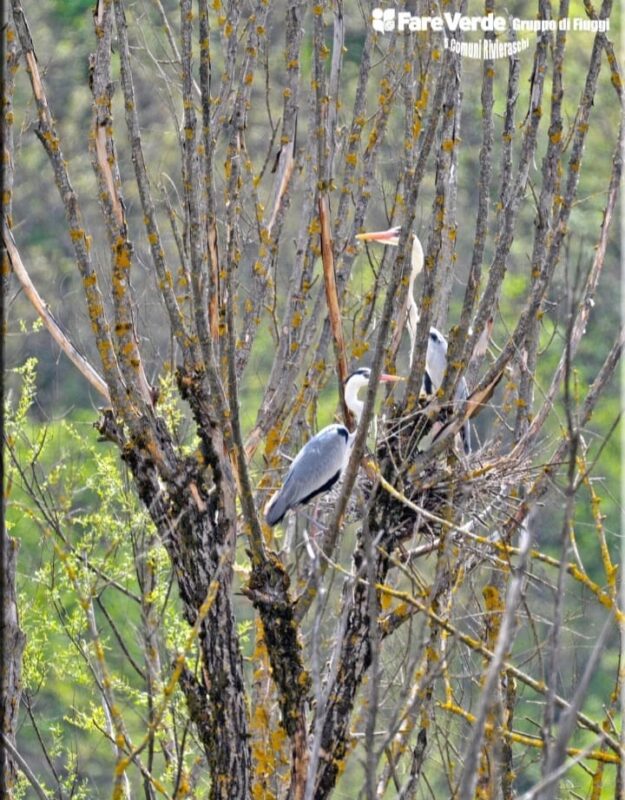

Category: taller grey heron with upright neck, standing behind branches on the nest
[356, 226, 471, 453]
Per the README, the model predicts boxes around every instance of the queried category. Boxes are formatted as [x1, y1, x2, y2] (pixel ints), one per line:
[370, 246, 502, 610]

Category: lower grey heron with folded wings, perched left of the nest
[265, 367, 402, 526]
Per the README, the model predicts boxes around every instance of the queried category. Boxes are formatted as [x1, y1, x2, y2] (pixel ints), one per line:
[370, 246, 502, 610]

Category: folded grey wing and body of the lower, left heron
[265, 425, 350, 525]
